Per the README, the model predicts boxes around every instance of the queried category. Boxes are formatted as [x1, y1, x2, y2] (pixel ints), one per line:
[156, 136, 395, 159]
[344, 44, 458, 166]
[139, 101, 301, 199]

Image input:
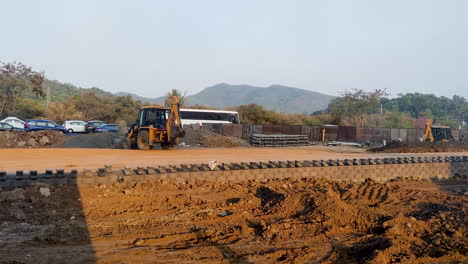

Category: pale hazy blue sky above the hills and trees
[0, 0, 468, 97]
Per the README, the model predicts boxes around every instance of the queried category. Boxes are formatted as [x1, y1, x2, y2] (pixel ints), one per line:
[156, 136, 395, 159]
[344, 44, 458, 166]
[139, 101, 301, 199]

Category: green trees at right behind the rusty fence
[322, 89, 468, 128]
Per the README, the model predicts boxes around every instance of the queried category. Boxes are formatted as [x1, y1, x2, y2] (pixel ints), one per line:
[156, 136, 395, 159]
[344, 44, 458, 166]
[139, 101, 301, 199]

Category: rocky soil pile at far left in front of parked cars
[0, 130, 66, 148]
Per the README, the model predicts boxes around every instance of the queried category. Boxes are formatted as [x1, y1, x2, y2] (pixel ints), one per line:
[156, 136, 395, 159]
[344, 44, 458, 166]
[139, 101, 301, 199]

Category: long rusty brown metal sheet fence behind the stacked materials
[203, 124, 468, 143]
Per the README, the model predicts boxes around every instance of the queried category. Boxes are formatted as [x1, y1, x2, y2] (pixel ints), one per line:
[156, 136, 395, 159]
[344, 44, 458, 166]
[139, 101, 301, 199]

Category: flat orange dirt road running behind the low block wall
[0, 147, 468, 171]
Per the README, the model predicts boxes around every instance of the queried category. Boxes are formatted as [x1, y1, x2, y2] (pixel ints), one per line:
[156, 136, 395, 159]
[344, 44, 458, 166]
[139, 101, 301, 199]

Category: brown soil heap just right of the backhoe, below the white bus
[180, 125, 250, 148]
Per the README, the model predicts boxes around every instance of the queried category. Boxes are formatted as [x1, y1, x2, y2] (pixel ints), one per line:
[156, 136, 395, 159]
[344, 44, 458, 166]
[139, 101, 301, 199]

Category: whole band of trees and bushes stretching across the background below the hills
[0, 62, 468, 128]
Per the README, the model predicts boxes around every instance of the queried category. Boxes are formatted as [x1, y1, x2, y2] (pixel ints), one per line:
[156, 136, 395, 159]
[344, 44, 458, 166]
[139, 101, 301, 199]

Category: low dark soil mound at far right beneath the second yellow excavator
[369, 141, 468, 153]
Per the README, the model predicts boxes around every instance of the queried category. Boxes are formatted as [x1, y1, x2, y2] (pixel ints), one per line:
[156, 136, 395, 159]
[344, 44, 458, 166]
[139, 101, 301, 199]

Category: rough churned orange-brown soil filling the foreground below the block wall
[0, 176, 468, 263]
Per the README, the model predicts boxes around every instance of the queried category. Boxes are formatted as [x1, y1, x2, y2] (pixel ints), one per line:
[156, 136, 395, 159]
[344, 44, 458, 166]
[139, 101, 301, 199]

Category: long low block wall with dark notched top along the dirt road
[0, 156, 468, 189]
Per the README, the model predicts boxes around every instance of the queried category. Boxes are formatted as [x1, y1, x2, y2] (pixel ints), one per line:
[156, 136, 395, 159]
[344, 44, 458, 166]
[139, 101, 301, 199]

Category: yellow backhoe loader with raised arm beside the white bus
[124, 96, 185, 150]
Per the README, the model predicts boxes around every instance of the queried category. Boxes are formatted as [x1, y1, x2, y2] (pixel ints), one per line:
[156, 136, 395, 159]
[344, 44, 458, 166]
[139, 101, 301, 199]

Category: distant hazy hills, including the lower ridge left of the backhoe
[40, 81, 335, 114]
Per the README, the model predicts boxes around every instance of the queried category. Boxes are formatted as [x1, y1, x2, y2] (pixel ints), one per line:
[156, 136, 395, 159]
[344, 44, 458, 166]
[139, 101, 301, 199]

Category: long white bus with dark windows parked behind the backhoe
[180, 109, 239, 125]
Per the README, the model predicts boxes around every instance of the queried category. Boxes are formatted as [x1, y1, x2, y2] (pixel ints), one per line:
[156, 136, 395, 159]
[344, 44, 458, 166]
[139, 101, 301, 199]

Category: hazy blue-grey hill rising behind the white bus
[188, 83, 335, 114]
